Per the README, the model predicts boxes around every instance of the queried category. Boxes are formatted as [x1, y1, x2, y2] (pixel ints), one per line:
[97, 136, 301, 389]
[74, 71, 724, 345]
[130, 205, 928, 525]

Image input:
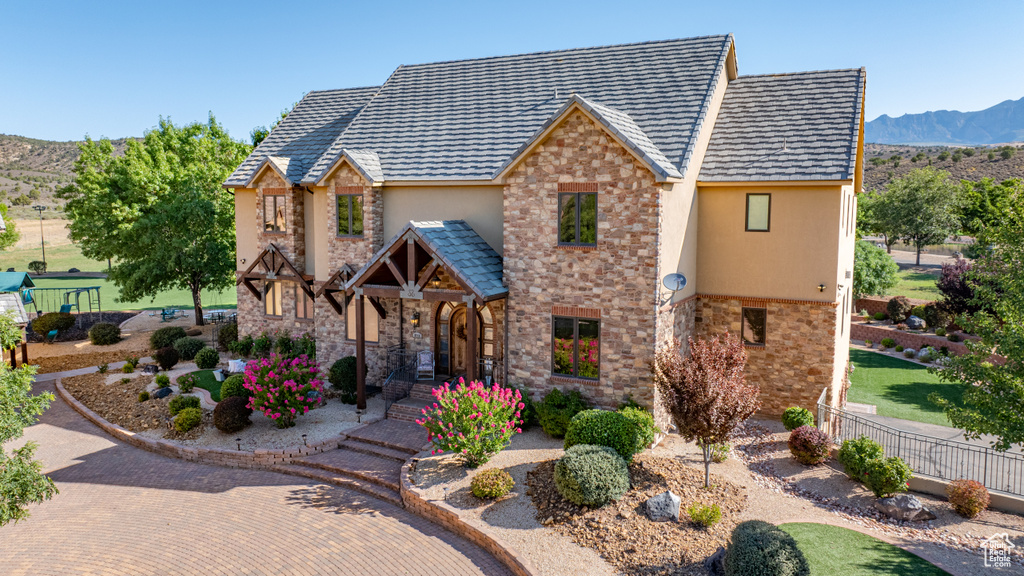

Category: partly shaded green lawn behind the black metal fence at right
[847, 349, 964, 426]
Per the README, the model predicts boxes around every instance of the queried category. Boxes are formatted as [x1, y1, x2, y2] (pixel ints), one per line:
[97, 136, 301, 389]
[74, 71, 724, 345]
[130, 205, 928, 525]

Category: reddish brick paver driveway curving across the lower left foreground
[0, 382, 506, 576]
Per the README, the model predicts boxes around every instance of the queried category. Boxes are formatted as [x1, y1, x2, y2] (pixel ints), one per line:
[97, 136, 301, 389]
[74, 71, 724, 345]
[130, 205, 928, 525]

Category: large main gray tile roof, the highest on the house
[302, 35, 732, 183]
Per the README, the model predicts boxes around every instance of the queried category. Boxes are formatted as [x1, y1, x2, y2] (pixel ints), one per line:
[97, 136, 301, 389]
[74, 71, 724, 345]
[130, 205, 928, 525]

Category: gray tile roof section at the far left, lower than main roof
[224, 86, 379, 187]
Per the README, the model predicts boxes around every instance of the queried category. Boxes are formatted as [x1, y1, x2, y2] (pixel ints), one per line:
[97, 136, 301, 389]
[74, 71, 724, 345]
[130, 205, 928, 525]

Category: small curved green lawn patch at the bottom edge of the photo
[779, 523, 949, 576]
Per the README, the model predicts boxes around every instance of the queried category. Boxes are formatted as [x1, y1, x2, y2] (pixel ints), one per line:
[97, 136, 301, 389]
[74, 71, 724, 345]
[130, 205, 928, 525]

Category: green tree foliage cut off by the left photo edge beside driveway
[0, 312, 57, 526]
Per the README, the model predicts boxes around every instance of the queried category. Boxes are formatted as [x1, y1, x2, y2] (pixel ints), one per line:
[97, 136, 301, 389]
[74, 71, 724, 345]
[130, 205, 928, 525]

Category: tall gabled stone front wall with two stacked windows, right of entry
[504, 111, 662, 407]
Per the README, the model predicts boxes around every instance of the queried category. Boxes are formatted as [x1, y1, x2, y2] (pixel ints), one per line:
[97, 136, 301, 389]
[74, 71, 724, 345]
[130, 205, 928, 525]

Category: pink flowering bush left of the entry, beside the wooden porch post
[244, 354, 324, 428]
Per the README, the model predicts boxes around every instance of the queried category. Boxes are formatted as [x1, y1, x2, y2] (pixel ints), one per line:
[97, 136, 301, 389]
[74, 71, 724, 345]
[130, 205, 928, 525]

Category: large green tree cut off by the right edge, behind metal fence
[930, 184, 1024, 450]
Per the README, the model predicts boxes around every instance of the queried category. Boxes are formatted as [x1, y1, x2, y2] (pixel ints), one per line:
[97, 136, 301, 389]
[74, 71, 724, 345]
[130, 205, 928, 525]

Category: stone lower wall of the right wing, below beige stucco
[695, 296, 848, 415]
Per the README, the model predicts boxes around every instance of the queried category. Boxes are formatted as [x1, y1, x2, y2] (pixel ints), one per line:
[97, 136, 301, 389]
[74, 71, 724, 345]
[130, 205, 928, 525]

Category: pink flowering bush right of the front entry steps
[416, 378, 525, 468]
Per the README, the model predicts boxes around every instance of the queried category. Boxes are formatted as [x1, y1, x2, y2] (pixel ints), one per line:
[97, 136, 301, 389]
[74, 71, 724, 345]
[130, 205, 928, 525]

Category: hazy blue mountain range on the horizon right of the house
[864, 98, 1024, 146]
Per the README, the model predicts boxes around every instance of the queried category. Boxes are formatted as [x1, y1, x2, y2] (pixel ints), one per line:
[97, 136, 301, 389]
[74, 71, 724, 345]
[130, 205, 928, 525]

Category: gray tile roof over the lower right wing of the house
[698, 69, 865, 181]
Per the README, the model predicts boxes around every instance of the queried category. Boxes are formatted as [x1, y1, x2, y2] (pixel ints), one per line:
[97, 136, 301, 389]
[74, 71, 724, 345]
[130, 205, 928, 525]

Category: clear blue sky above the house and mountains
[0, 0, 1024, 140]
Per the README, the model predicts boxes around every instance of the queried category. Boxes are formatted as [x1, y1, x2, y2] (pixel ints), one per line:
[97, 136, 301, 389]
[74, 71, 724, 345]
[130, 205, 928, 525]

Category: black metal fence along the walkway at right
[818, 394, 1024, 496]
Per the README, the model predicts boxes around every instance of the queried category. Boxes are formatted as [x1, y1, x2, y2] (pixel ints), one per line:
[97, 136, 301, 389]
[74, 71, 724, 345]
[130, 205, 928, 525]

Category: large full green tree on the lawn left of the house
[58, 115, 252, 326]
